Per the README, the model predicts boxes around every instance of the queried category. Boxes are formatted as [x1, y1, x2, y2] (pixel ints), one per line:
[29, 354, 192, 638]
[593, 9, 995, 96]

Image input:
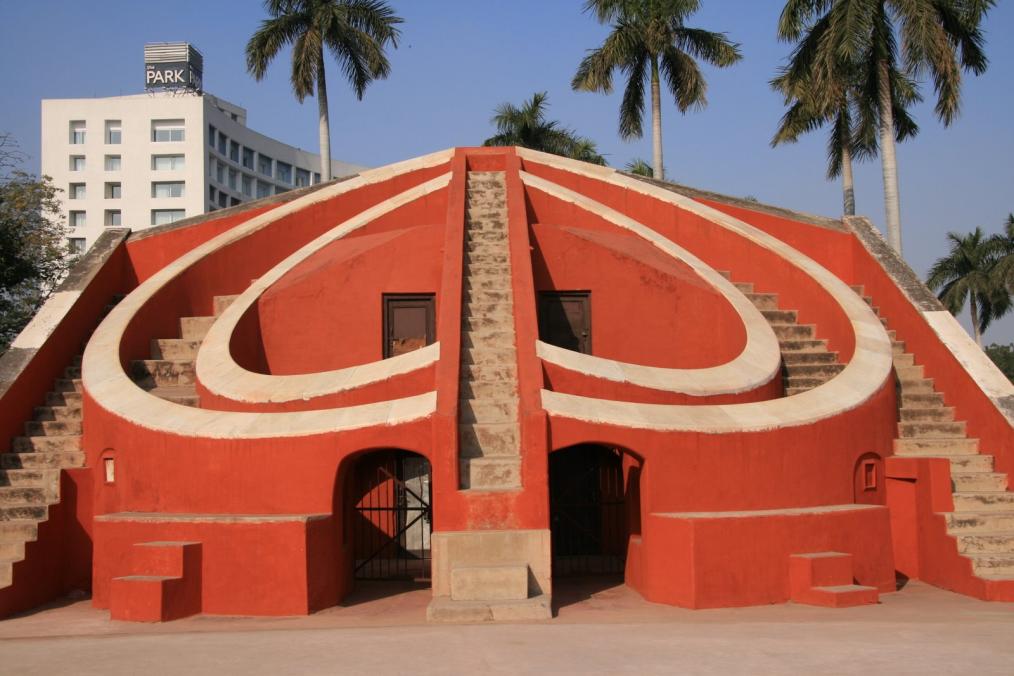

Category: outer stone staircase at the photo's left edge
[0, 356, 84, 589]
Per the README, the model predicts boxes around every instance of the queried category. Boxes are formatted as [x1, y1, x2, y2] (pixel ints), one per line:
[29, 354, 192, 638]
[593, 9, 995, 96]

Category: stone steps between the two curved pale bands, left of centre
[131, 296, 237, 406]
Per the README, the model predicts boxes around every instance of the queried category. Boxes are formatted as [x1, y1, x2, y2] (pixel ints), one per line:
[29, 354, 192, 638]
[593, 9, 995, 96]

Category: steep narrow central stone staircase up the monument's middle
[458, 171, 521, 491]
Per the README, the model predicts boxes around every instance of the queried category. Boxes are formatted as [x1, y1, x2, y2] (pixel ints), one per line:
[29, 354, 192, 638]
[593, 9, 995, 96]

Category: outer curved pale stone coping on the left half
[82, 150, 452, 439]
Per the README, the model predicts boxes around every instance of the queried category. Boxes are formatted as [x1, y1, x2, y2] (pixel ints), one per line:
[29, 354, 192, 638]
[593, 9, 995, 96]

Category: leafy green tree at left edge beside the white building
[0, 169, 74, 353]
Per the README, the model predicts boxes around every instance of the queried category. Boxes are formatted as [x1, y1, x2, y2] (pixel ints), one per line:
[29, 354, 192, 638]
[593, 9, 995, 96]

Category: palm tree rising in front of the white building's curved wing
[246, 0, 402, 181]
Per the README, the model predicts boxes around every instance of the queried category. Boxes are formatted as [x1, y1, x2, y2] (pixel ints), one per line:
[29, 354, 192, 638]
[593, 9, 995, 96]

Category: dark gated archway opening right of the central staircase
[550, 445, 628, 577]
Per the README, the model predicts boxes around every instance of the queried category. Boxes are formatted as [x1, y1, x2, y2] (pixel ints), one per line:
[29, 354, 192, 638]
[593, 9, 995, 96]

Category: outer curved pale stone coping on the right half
[517, 148, 892, 434]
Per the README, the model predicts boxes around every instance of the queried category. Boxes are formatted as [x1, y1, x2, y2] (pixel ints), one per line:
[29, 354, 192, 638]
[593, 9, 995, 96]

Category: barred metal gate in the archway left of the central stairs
[352, 451, 433, 581]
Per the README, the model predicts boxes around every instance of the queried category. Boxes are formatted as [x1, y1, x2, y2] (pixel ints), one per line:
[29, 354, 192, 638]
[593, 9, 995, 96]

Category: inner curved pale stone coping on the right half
[521, 171, 782, 396]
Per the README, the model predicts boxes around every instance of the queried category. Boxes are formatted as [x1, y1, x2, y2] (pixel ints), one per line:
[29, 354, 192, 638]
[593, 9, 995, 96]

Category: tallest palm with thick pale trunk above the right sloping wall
[778, 0, 996, 253]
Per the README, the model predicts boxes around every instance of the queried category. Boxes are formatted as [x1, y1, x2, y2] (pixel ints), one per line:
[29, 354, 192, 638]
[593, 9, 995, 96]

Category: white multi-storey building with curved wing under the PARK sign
[42, 43, 362, 250]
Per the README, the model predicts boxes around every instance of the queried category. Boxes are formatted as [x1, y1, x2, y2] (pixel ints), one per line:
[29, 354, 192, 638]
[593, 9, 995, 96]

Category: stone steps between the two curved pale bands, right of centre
[719, 272, 845, 396]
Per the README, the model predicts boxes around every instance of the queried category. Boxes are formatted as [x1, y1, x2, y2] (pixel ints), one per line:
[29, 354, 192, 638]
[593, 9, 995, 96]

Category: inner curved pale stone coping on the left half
[197, 173, 450, 403]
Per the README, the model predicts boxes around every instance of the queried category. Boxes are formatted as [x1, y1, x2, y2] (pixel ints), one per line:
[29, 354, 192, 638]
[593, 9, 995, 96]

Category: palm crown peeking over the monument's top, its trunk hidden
[483, 91, 605, 164]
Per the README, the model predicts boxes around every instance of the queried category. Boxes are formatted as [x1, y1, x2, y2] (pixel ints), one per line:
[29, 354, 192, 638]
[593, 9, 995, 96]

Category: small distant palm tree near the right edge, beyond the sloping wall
[926, 228, 1010, 347]
